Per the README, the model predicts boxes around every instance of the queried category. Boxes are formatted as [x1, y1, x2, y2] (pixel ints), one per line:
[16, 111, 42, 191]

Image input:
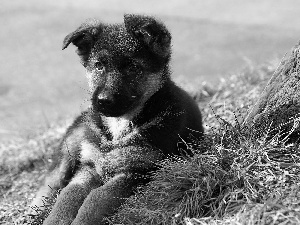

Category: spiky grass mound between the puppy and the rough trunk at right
[112, 60, 300, 225]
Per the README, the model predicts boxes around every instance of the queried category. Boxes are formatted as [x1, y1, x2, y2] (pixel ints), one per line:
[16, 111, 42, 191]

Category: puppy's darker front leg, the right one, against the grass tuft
[72, 173, 144, 225]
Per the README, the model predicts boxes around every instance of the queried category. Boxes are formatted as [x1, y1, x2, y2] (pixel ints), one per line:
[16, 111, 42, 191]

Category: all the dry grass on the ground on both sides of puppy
[0, 60, 300, 225]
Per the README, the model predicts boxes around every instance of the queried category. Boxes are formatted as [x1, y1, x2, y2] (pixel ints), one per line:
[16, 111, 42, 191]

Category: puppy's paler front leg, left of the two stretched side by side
[43, 168, 101, 225]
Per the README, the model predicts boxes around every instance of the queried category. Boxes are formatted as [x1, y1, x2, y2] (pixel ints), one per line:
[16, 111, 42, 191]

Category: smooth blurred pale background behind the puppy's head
[0, 0, 300, 141]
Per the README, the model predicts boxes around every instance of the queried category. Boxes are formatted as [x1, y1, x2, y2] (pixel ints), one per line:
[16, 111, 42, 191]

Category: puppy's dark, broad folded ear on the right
[124, 14, 171, 57]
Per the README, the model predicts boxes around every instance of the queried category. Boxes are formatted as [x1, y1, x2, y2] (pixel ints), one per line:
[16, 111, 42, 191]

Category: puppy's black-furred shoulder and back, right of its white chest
[135, 81, 203, 154]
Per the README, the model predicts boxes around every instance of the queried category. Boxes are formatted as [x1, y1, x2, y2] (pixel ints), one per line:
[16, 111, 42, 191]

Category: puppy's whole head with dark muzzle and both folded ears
[63, 15, 171, 117]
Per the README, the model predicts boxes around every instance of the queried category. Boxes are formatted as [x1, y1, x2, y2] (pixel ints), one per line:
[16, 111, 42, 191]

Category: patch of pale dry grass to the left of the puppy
[0, 122, 69, 225]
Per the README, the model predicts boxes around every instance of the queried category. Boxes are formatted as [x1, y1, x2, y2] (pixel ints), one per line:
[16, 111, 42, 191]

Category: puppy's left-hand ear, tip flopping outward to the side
[62, 19, 103, 64]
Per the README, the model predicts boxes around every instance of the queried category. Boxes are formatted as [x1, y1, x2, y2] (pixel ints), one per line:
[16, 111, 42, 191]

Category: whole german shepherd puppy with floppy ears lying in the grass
[33, 15, 203, 225]
